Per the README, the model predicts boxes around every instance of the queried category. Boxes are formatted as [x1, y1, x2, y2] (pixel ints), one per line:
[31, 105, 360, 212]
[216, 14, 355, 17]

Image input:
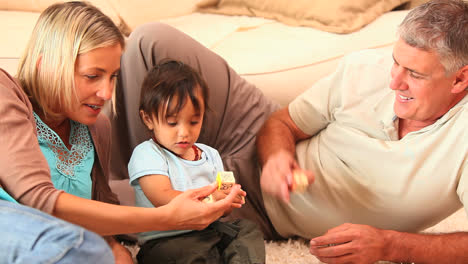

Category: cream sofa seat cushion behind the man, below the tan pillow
[163, 10, 408, 106]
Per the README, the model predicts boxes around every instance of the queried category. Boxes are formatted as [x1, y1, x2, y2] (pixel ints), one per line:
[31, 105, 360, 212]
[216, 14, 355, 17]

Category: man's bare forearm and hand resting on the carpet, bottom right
[310, 224, 468, 264]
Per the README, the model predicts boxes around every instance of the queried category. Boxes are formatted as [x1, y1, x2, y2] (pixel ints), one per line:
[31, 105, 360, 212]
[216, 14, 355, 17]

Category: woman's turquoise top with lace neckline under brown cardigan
[34, 113, 95, 199]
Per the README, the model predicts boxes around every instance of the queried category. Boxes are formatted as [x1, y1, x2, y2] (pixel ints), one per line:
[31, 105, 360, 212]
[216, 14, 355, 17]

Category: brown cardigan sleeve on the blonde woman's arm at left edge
[0, 70, 63, 214]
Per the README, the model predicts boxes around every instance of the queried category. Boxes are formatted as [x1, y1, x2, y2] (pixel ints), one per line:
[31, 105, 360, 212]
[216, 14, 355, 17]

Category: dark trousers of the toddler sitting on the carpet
[137, 219, 265, 264]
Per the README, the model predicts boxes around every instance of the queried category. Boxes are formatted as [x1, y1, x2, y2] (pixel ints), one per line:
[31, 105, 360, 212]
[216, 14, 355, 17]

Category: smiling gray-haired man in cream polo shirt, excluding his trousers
[257, 0, 468, 263]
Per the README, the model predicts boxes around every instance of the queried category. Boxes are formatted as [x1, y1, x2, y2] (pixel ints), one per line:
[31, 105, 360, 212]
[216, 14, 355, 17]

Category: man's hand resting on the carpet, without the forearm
[310, 224, 388, 264]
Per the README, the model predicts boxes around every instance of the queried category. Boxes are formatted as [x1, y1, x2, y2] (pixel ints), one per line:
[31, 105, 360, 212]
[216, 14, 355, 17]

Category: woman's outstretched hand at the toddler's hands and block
[160, 183, 245, 230]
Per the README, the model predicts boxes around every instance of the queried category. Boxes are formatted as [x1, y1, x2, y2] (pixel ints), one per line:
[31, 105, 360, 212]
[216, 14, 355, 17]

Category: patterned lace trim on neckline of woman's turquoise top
[34, 113, 94, 177]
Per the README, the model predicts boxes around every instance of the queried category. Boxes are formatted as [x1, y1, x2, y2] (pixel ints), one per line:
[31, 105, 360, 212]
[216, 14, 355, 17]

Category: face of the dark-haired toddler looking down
[144, 92, 205, 159]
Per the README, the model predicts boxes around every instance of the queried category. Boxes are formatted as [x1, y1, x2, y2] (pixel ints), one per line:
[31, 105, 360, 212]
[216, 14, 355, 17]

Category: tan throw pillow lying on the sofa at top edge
[199, 0, 409, 33]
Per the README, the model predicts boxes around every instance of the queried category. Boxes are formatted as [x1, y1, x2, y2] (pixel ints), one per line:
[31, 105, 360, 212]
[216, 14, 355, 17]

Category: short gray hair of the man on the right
[398, 0, 468, 74]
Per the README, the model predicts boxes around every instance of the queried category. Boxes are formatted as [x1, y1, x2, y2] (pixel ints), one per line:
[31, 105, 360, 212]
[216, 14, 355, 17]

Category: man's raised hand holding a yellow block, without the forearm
[260, 151, 314, 202]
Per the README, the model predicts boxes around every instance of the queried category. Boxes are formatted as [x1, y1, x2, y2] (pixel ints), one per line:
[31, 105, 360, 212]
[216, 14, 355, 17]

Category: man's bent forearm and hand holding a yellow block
[256, 107, 313, 201]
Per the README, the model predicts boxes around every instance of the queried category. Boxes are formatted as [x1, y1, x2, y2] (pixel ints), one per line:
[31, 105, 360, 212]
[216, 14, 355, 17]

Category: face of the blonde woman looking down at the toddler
[65, 44, 122, 125]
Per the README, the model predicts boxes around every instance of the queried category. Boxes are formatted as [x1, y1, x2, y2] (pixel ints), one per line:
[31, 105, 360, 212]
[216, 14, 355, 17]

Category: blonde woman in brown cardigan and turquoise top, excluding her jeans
[0, 2, 241, 263]
